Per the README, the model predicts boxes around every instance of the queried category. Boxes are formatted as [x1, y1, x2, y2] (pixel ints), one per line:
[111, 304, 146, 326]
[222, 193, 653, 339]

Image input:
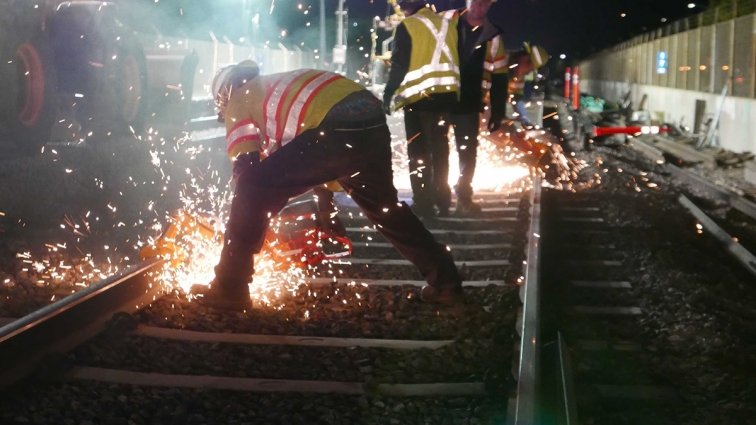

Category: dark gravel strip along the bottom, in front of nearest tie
[0, 382, 505, 425]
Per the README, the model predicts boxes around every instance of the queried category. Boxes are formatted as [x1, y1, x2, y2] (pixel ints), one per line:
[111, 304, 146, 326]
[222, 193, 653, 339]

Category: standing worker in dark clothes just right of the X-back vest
[451, 0, 509, 217]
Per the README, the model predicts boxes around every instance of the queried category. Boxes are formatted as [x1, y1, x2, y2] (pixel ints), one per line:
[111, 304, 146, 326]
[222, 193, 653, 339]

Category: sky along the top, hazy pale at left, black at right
[117, 0, 705, 60]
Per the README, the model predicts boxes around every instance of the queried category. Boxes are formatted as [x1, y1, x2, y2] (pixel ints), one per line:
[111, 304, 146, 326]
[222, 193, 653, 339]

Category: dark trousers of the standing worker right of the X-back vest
[451, 112, 480, 202]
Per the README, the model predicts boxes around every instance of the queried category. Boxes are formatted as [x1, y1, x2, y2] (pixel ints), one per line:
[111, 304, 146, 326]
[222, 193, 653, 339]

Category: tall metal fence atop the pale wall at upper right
[580, 0, 756, 98]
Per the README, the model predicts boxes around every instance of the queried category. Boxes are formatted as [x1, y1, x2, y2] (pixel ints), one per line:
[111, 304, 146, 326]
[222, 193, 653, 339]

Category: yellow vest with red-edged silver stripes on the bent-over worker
[224, 69, 364, 160]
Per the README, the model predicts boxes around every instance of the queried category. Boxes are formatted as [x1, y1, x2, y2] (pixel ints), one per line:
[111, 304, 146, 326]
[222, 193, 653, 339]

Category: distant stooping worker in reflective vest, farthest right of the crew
[509, 43, 549, 127]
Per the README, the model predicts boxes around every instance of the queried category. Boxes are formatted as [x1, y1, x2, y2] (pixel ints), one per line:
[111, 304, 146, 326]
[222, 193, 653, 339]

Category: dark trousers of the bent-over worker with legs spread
[215, 116, 461, 287]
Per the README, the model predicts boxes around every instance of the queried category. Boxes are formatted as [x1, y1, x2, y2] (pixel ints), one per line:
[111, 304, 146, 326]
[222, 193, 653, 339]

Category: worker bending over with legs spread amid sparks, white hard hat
[200, 61, 463, 310]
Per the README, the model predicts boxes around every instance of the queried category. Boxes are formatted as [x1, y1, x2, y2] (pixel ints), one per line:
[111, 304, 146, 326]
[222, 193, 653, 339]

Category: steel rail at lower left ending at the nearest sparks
[0, 259, 163, 389]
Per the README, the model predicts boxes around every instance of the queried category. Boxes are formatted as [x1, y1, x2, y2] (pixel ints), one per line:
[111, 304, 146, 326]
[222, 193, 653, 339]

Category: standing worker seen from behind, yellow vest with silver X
[383, 0, 459, 218]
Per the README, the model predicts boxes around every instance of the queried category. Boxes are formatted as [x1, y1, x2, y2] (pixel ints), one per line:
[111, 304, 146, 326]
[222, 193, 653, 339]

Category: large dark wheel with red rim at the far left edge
[11, 33, 58, 154]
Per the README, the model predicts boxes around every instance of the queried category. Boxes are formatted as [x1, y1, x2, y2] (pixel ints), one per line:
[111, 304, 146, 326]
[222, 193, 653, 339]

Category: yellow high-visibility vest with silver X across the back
[394, 8, 459, 109]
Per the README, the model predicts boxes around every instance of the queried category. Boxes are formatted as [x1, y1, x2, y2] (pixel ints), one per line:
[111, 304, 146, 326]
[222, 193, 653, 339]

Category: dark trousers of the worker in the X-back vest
[404, 106, 451, 211]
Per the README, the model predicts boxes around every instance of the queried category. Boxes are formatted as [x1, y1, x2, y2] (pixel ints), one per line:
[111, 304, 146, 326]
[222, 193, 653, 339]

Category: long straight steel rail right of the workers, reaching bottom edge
[510, 173, 541, 425]
